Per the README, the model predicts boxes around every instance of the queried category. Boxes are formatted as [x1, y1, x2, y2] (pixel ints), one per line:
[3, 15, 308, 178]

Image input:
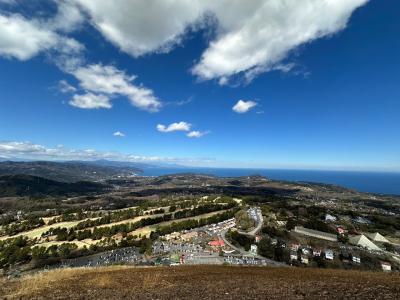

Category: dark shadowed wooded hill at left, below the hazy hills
[0, 175, 108, 197]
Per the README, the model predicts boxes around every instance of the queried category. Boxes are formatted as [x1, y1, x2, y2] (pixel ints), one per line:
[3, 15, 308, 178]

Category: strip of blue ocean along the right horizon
[143, 168, 400, 195]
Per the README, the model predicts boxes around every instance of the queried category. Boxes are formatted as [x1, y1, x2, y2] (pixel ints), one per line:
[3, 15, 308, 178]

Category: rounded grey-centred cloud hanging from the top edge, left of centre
[74, 0, 208, 57]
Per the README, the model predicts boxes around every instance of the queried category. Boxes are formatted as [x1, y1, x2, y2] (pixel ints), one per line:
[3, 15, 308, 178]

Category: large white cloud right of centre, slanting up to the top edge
[192, 0, 368, 80]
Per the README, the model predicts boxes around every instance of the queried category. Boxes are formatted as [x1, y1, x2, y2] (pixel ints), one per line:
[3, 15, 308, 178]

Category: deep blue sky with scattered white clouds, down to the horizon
[0, 0, 400, 171]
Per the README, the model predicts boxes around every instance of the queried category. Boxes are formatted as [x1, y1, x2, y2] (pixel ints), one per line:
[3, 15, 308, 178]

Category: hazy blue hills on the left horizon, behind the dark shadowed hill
[0, 160, 145, 182]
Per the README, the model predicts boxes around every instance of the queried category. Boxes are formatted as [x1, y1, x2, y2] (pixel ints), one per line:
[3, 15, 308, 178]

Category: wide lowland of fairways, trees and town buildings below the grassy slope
[0, 166, 400, 277]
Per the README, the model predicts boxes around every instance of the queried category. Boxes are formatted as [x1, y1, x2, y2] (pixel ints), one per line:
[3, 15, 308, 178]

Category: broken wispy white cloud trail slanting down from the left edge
[0, 11, 161, 112]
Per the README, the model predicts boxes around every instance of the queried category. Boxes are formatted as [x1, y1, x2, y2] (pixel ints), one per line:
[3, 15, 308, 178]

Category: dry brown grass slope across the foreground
[0, 266, 400, 300]
